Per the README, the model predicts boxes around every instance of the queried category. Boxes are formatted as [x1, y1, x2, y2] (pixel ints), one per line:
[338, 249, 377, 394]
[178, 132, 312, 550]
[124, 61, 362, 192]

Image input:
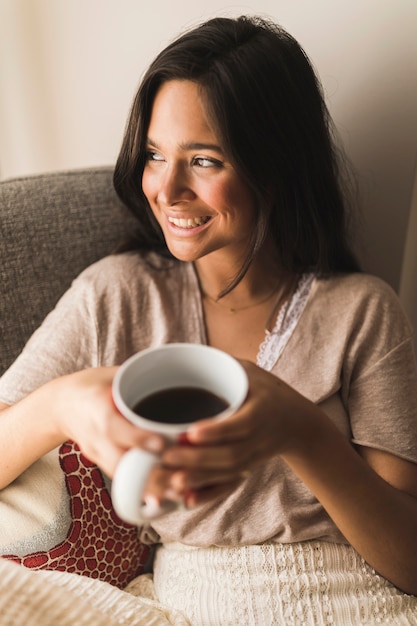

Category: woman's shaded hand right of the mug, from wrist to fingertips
[158, 361, 319, 506]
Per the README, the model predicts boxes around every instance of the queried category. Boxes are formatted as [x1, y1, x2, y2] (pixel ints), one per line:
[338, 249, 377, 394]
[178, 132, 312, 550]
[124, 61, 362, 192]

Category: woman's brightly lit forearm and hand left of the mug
[0, 367, 164, 489]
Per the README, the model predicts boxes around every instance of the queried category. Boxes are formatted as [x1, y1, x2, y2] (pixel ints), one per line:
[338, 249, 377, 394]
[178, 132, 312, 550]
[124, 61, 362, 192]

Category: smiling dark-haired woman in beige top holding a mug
[0, 18, 417, 626]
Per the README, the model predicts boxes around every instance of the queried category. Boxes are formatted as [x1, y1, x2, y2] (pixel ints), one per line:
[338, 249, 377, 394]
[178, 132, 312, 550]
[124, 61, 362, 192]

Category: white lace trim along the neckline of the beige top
[256, 273, 315, 371]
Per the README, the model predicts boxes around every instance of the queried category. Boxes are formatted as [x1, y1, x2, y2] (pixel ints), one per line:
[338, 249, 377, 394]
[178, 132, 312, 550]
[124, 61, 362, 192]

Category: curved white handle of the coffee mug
[111, 448, 178, 526]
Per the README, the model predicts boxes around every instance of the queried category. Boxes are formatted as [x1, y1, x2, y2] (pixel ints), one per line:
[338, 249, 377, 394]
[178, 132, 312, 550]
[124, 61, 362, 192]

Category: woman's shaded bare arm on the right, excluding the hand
[283, 404, 417, 595]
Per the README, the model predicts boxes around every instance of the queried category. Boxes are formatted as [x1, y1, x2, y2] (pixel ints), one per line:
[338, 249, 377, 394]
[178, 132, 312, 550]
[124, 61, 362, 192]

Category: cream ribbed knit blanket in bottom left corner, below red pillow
[0, 559, 189, 626]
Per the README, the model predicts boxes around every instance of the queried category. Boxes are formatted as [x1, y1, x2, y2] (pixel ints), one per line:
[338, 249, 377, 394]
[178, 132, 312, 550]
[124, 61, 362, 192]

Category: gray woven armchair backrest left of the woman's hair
[0, 167, 132, 375]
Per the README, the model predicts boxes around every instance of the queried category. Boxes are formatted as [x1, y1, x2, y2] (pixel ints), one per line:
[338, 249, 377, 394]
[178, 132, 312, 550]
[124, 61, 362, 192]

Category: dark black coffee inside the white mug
[133, 387, 229, 424]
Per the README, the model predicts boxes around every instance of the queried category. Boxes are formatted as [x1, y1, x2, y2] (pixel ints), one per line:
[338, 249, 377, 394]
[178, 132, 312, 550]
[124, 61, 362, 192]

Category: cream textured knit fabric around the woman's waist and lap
[154, 541, 417, 626]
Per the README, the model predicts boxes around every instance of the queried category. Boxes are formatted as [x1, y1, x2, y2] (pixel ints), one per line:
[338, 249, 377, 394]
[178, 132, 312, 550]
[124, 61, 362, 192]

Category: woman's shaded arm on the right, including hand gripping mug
[163, 356, 417, 595]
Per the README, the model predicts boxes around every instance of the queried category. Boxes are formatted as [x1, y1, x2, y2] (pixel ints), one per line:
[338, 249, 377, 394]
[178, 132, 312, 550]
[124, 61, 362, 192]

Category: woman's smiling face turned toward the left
[142, 80, 257, 263]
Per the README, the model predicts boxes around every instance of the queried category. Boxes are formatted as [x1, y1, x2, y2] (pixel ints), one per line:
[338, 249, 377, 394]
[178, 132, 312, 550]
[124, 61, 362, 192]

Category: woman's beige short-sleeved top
[0, 253, 417, 546]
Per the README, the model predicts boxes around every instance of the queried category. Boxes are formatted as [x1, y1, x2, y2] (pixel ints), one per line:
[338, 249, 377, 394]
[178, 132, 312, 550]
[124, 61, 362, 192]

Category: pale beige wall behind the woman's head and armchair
[0, 0, 417, 336]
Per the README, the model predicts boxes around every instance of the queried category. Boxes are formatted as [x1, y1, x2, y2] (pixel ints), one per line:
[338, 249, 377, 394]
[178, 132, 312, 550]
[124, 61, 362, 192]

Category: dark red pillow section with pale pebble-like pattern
[0, 441, 151, 588]
